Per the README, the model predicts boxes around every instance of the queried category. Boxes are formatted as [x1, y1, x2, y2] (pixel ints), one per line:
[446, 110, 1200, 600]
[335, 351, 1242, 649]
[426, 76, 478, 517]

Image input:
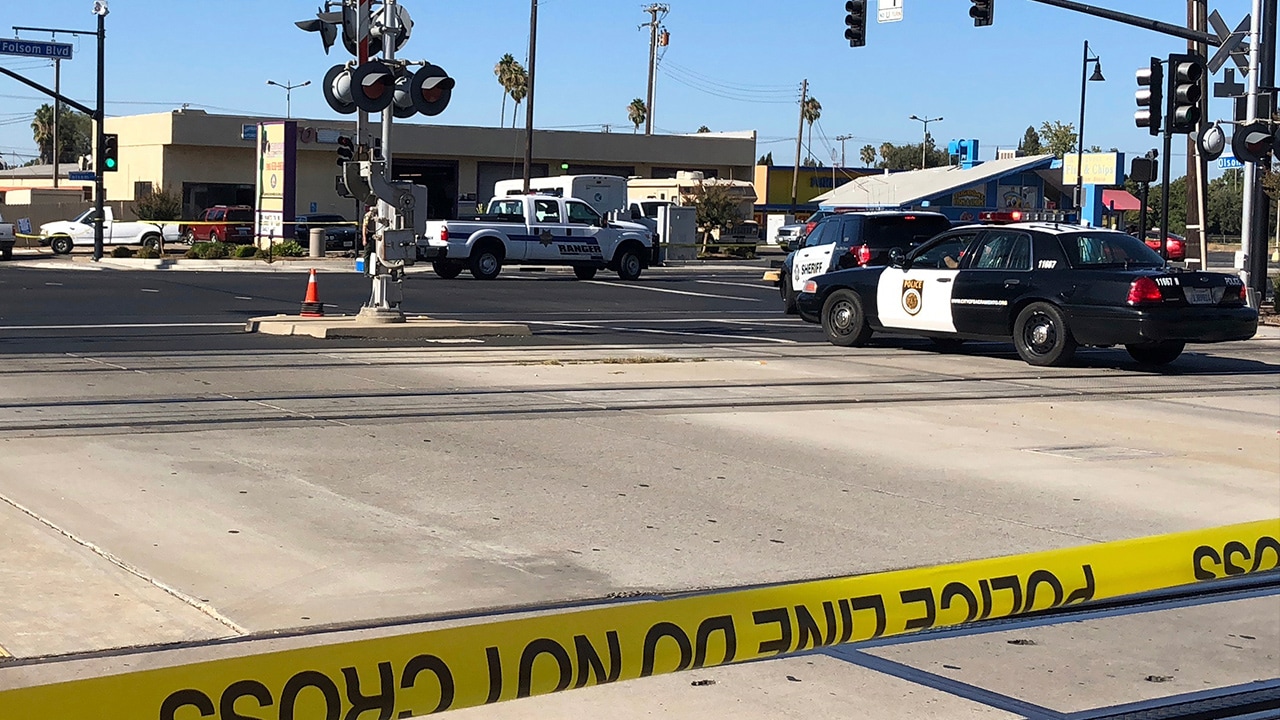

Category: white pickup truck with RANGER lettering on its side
[419, 195, 653, 281]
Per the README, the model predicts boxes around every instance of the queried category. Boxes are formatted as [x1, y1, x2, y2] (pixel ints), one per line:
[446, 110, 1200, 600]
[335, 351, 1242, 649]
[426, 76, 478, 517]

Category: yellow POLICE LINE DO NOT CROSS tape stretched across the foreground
[0, 519, 1280, 720]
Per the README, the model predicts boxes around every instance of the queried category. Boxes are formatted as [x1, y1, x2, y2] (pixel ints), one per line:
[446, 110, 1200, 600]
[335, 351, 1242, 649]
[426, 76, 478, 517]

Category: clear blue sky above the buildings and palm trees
[0, 0, 1251, 174]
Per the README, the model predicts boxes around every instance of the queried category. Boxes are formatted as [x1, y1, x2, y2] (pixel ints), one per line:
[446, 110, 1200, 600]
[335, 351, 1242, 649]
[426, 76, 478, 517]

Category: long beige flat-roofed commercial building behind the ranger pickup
[105, 109, 755, 219]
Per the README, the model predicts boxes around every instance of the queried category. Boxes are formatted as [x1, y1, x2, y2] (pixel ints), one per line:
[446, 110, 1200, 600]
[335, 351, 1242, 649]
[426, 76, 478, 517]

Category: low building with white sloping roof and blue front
[814, 155, 1070, 222]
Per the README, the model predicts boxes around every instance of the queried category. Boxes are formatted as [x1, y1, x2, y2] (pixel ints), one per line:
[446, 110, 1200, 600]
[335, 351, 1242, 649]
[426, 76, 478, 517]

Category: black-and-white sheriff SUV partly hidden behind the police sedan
[778, 210, 951, 314]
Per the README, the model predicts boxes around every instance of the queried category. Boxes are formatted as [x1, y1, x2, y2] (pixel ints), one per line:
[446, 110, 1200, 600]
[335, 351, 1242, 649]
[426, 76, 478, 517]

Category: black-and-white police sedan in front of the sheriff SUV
[796, 223, 1258, 365]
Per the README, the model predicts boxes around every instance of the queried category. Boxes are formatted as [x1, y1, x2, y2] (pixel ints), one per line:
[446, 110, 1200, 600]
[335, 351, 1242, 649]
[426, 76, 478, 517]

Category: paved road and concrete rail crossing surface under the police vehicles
[0, 260, 1280, 720]
